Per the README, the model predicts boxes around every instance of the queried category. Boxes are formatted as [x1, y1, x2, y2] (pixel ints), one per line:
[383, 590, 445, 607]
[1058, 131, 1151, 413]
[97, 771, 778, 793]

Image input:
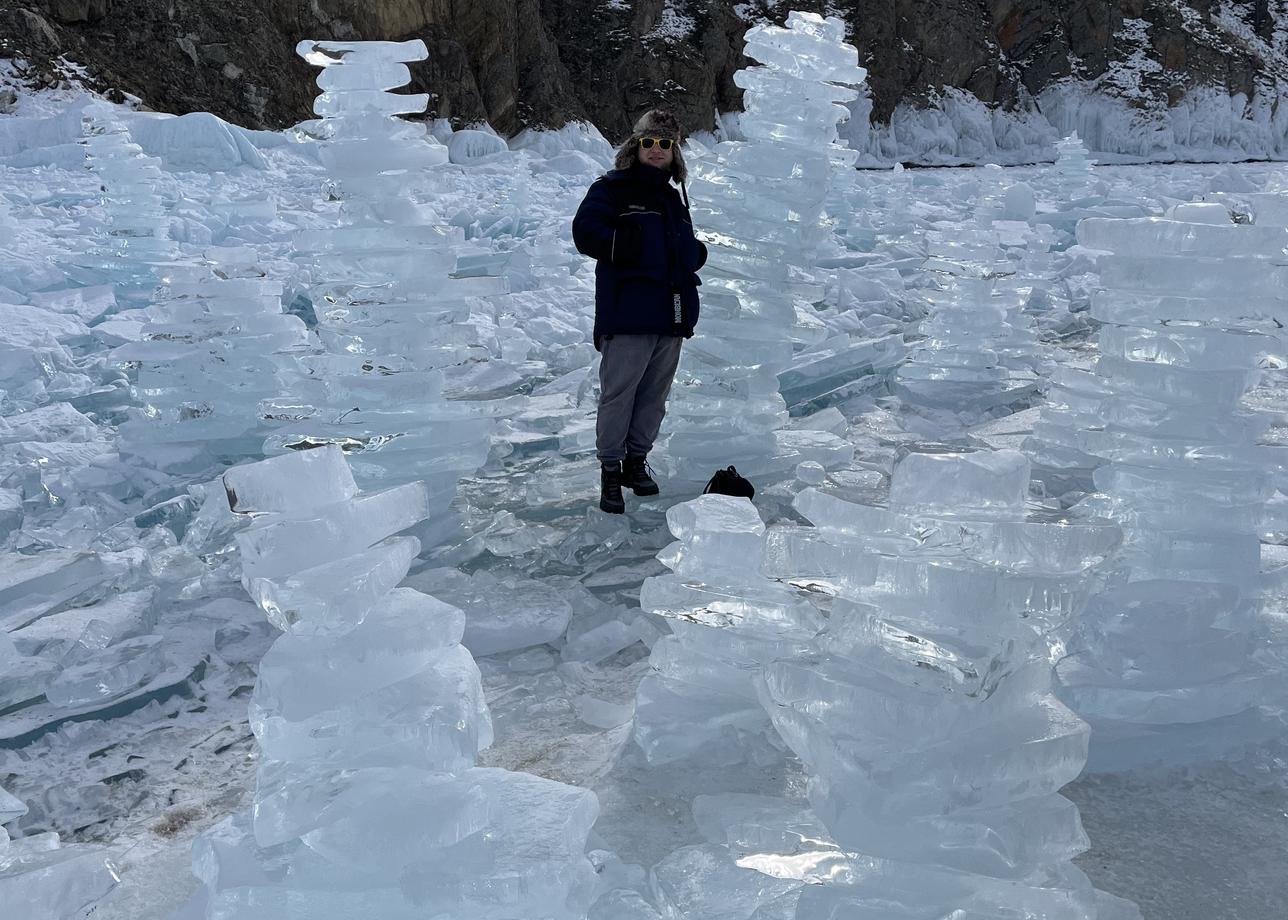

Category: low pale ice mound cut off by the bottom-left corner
[0, 789, 118, 920]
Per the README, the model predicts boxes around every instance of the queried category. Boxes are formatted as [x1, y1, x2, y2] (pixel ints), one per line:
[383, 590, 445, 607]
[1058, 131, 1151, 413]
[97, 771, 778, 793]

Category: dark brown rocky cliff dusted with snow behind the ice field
[0, 0, 1288, 138]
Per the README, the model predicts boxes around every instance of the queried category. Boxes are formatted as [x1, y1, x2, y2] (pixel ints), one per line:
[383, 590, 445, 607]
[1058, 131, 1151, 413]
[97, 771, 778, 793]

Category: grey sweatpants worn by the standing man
[595, 335, 684, 463]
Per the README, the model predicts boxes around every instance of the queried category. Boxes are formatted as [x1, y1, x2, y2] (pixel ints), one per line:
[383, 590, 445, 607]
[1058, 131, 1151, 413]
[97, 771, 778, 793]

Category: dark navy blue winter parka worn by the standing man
[572, 162, 707, 349]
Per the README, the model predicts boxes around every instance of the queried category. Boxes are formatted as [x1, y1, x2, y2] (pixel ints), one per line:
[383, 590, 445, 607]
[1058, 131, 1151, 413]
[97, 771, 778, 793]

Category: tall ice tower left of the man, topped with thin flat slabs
[261, 40, 504, 502]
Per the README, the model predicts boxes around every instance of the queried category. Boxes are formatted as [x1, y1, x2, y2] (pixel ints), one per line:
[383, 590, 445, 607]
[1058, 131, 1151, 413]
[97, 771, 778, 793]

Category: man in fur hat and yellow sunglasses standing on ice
[572, 108, 707, 514]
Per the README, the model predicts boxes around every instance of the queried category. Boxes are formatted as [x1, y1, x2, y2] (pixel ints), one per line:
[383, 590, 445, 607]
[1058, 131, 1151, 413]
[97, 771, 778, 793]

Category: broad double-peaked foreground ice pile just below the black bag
[638, 451, 1139, 920]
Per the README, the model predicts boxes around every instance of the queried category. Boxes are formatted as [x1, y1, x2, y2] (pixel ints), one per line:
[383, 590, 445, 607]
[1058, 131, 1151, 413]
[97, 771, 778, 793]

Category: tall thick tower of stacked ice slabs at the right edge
[1033, 211, 1288, 771]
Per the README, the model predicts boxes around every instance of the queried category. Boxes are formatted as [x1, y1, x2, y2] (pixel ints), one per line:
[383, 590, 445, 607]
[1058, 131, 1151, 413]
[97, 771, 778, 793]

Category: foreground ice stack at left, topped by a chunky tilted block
[186, 447, 598, 920]
